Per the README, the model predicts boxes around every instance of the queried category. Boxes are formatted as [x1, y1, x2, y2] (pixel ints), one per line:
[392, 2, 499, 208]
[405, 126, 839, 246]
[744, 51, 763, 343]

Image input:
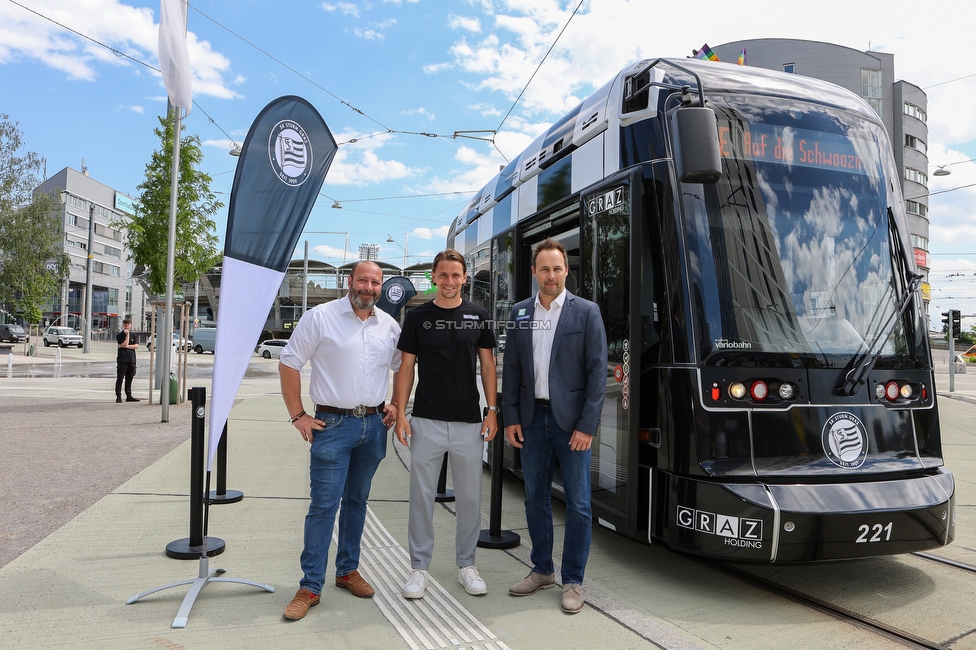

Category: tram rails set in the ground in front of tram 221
[697, 553, 952, 650]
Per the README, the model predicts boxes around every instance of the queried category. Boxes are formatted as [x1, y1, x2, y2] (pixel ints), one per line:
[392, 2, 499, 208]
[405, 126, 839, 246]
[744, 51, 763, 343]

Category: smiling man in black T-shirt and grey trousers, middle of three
[393, 249, 498, 598]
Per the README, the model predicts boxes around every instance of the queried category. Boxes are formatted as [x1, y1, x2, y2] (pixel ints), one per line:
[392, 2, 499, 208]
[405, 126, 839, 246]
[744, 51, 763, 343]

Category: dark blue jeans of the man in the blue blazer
[521, 404, 593, 585]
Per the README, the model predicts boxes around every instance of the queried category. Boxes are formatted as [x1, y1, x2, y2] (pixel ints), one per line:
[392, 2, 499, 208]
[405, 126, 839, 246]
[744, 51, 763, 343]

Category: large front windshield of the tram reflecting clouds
[682, 96, 924, 367]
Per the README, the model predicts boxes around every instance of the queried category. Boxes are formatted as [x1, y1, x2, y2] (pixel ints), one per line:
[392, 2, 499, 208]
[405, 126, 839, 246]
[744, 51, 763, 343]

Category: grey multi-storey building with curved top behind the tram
[711, 38, 931, 313]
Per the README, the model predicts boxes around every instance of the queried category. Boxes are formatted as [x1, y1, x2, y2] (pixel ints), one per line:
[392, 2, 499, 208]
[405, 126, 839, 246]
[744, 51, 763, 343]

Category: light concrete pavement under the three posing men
[0, 353, 697, 649]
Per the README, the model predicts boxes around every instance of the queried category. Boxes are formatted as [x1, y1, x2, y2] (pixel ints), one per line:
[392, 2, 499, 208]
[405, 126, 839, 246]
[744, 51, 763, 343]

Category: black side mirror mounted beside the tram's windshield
[671, 106, 722, 183]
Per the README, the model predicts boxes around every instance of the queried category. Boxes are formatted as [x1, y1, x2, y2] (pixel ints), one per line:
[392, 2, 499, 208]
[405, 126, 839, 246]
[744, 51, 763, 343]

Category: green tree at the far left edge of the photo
[0, 113, 70, 323]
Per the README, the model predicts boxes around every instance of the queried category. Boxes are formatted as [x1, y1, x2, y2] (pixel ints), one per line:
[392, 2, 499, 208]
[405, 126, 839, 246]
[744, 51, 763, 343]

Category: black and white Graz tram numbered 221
[447, 59, 955, 563]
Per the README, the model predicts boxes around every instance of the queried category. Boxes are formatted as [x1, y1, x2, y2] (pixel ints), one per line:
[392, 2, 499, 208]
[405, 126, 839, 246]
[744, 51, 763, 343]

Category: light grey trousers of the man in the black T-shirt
[407, 417, 485, 571]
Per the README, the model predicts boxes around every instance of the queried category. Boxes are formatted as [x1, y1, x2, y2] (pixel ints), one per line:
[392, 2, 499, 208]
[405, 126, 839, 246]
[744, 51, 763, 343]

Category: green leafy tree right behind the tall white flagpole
[119, 112, 223, 295]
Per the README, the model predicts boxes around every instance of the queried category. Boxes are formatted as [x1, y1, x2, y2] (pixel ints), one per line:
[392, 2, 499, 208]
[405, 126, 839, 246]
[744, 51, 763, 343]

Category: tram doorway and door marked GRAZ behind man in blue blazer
[508, 172, 641, 533]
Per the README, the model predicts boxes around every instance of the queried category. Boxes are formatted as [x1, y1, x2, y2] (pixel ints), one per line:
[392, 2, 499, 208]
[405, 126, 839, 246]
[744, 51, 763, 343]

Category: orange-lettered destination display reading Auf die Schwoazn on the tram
[718, 120, 881, 178]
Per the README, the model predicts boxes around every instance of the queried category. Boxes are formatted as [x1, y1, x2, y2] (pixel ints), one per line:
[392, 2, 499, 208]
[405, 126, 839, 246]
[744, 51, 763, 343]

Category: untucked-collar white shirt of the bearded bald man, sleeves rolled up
[281, 296, 400, 409]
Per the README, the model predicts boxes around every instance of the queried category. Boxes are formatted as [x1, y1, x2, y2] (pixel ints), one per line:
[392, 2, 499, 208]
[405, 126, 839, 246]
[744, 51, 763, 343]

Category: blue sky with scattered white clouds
[0, 0, 976, 330]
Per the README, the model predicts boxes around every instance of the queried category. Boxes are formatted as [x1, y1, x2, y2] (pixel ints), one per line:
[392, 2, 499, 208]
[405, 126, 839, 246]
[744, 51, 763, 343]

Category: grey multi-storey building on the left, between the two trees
[36, 167, 148, 338]
